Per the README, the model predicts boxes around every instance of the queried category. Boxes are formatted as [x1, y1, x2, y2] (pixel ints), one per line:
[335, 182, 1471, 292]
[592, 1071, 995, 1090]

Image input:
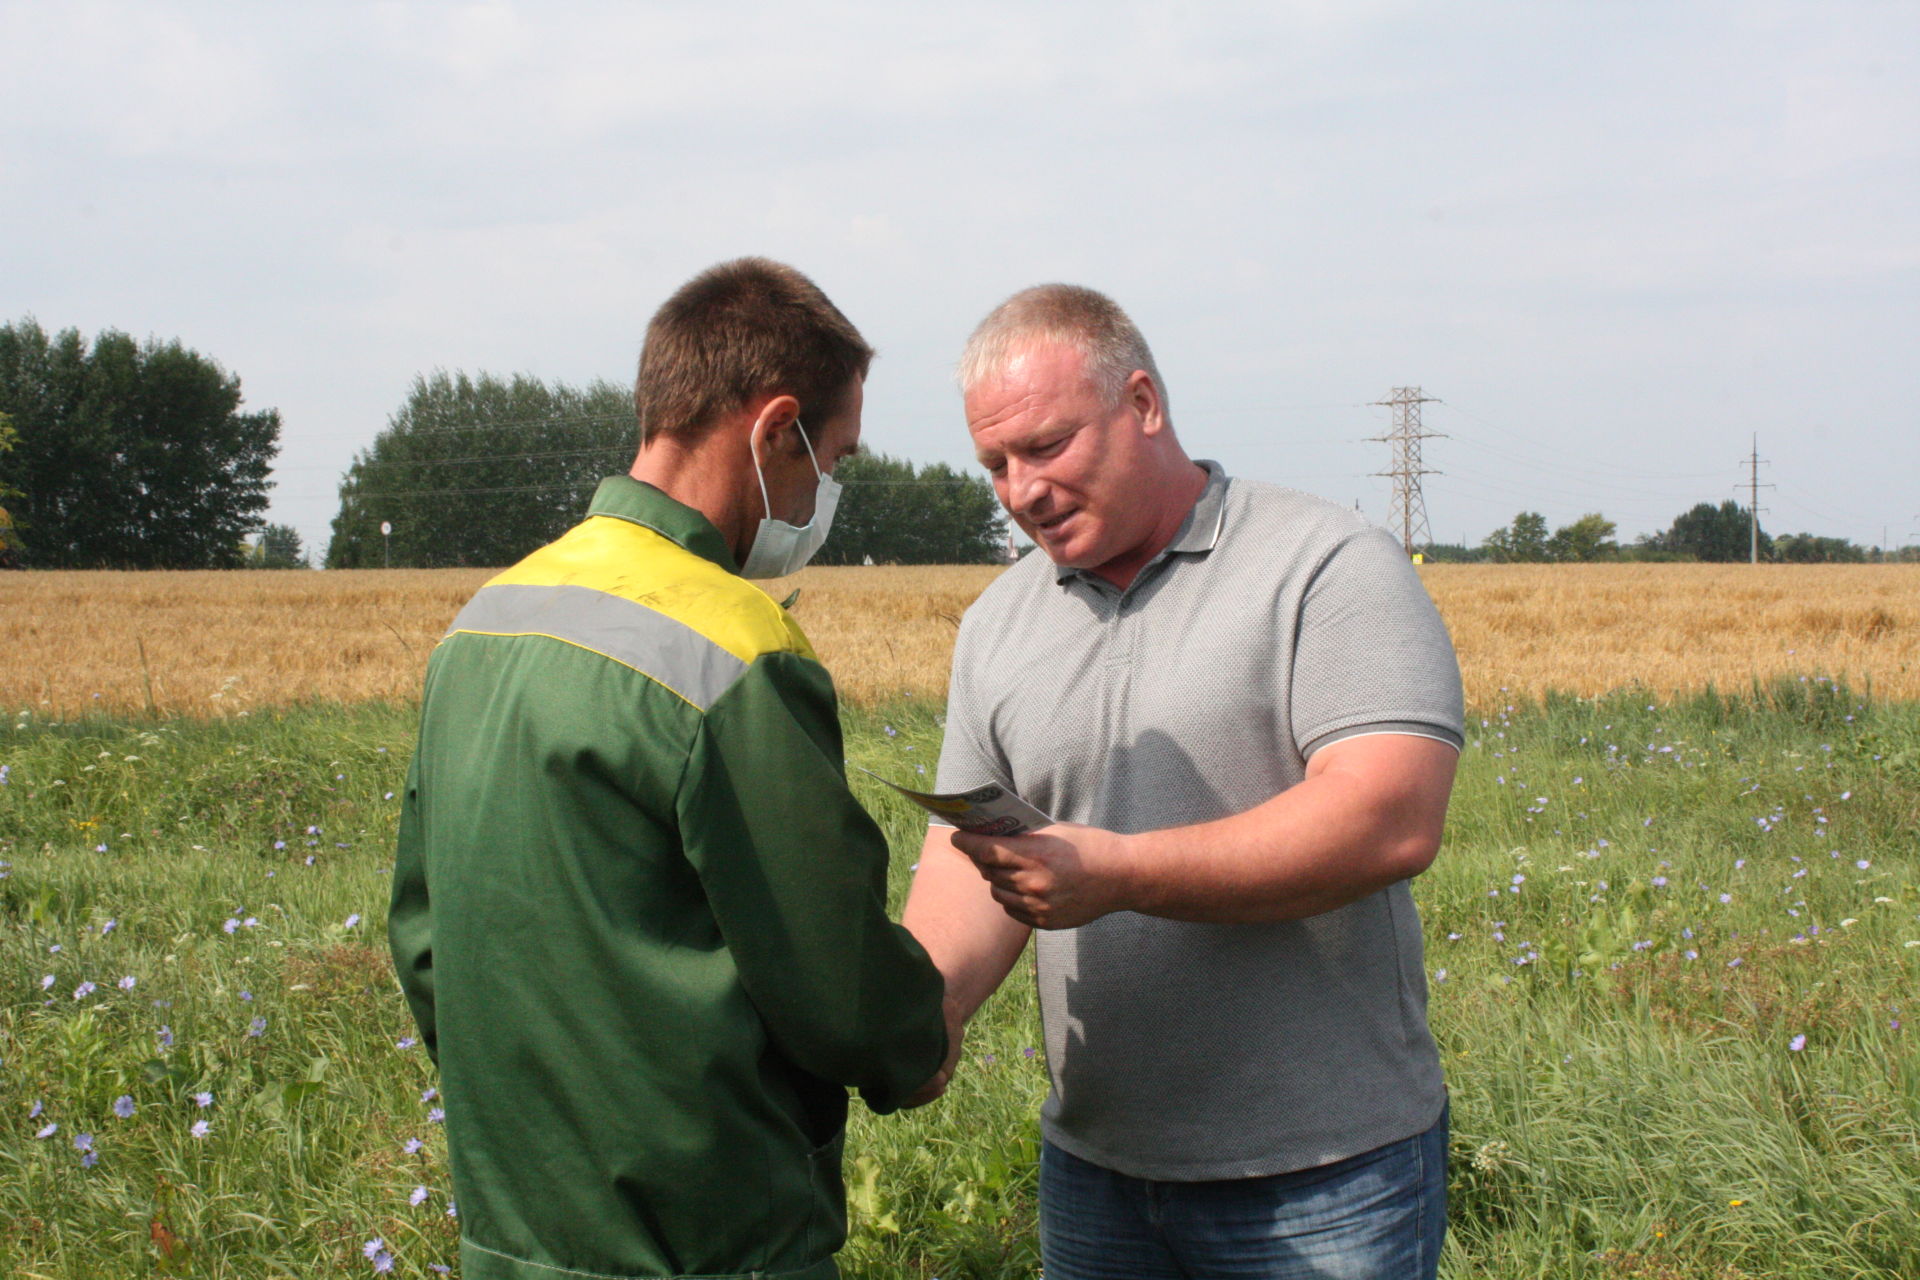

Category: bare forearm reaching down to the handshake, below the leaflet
[900, 827, 1031, 1023]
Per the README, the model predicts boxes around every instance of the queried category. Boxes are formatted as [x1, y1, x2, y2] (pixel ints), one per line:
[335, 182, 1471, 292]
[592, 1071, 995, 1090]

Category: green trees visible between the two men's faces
[814, 453, 1006, 564]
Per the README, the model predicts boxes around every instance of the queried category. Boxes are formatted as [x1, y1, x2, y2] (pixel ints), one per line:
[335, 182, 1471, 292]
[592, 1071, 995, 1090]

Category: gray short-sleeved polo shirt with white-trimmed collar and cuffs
[939, 462, 1463, 1180]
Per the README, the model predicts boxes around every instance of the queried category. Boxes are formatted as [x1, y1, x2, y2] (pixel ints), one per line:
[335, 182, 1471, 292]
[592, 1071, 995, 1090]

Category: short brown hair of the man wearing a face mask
[634, 257, 874, 443]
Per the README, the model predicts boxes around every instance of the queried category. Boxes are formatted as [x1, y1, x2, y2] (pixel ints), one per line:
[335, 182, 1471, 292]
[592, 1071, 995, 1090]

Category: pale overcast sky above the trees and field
[0, 0, 1920, 551]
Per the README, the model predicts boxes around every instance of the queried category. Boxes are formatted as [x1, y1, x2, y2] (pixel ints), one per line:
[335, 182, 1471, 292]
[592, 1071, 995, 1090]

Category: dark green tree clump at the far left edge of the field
[0, 319, 280, 568]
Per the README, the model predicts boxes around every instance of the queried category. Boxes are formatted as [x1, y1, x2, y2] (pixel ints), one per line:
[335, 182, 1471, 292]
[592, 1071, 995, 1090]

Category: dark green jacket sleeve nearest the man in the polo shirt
[676, 652, 947, 1113]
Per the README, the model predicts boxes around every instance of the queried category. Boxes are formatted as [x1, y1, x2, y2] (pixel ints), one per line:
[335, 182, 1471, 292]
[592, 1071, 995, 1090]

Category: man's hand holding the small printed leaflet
[952, 821, 1131, 929]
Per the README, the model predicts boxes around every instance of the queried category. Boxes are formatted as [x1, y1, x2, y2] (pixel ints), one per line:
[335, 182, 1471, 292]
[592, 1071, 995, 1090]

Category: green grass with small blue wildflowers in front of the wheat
[0, 679, 1920, 1280]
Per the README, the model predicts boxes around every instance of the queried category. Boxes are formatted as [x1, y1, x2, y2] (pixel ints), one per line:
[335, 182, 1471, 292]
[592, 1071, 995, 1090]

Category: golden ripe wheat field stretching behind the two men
[0, 564, 1920, 716]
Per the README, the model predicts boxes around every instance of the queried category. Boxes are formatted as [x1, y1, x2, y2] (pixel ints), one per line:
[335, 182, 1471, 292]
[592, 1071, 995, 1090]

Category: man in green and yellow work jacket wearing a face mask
[388, 259, 950, 1280]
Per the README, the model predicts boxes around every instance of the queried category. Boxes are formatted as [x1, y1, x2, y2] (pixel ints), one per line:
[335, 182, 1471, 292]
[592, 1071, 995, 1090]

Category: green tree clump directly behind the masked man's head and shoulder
[326, 370, 637, 568]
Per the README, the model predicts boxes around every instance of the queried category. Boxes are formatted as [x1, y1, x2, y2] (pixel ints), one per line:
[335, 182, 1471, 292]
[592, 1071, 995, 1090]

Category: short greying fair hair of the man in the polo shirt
[958, 284, 1167, 413]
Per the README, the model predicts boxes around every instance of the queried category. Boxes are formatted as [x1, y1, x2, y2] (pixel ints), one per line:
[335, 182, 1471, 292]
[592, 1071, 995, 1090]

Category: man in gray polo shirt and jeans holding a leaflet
[906, 286, 1461, 1280]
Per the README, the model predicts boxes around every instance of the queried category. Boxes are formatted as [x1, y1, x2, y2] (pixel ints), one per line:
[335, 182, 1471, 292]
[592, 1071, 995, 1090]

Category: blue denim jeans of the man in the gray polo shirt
[1041, 1111, 1448, 1280]
